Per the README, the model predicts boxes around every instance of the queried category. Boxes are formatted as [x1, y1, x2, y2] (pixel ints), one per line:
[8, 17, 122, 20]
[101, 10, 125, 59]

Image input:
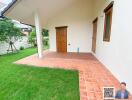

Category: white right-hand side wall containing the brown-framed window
[93, 0, 132, 92]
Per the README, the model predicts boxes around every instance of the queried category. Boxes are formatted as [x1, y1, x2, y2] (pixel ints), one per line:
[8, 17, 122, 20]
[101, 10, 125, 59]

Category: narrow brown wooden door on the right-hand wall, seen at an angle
[92, 18, 98, 53]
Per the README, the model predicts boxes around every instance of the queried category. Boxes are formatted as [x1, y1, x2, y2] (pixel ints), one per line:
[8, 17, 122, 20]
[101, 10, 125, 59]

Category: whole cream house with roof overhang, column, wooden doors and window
[2, 0, 132, 92]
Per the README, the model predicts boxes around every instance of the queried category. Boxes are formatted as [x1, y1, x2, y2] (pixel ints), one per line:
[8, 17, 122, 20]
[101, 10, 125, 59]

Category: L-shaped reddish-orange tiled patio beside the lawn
[16, 51, 131, 100]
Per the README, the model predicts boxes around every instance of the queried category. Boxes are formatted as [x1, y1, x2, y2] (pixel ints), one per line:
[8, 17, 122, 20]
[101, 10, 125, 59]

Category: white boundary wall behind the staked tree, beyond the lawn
[0, 36, 31, 55]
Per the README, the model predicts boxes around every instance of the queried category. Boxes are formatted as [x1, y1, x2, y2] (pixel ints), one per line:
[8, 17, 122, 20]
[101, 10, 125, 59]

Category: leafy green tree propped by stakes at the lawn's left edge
[0, 18, 22, 52]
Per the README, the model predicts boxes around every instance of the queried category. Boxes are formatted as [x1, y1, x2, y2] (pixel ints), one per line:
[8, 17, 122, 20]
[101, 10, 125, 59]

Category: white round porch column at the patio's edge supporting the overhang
[34, 12, 43, 58]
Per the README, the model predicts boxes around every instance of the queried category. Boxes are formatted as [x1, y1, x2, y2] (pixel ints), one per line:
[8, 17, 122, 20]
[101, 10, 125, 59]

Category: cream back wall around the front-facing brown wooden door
[47, 0, 92, 52]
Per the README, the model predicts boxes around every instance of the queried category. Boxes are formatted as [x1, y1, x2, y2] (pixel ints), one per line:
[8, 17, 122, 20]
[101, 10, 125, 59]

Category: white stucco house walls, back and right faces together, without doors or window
[47, 0, 132, 92]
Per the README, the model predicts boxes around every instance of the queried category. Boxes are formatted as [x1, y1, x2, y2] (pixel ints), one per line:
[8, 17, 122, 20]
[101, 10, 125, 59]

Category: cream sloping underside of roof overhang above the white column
[3, 0, 77, 27]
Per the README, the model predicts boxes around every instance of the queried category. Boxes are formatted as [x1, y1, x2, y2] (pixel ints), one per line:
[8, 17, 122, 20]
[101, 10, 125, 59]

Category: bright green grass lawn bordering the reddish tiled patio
[0, 48, 79, 100]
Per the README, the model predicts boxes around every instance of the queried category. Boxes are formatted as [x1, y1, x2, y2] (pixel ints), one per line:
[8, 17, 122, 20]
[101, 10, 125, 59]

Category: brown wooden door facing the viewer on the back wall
[56, 26, 67, 53]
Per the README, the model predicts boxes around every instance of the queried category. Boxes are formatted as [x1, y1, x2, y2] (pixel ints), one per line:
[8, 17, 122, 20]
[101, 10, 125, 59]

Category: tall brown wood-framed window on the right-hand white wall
[103, 2, 114, 42]
